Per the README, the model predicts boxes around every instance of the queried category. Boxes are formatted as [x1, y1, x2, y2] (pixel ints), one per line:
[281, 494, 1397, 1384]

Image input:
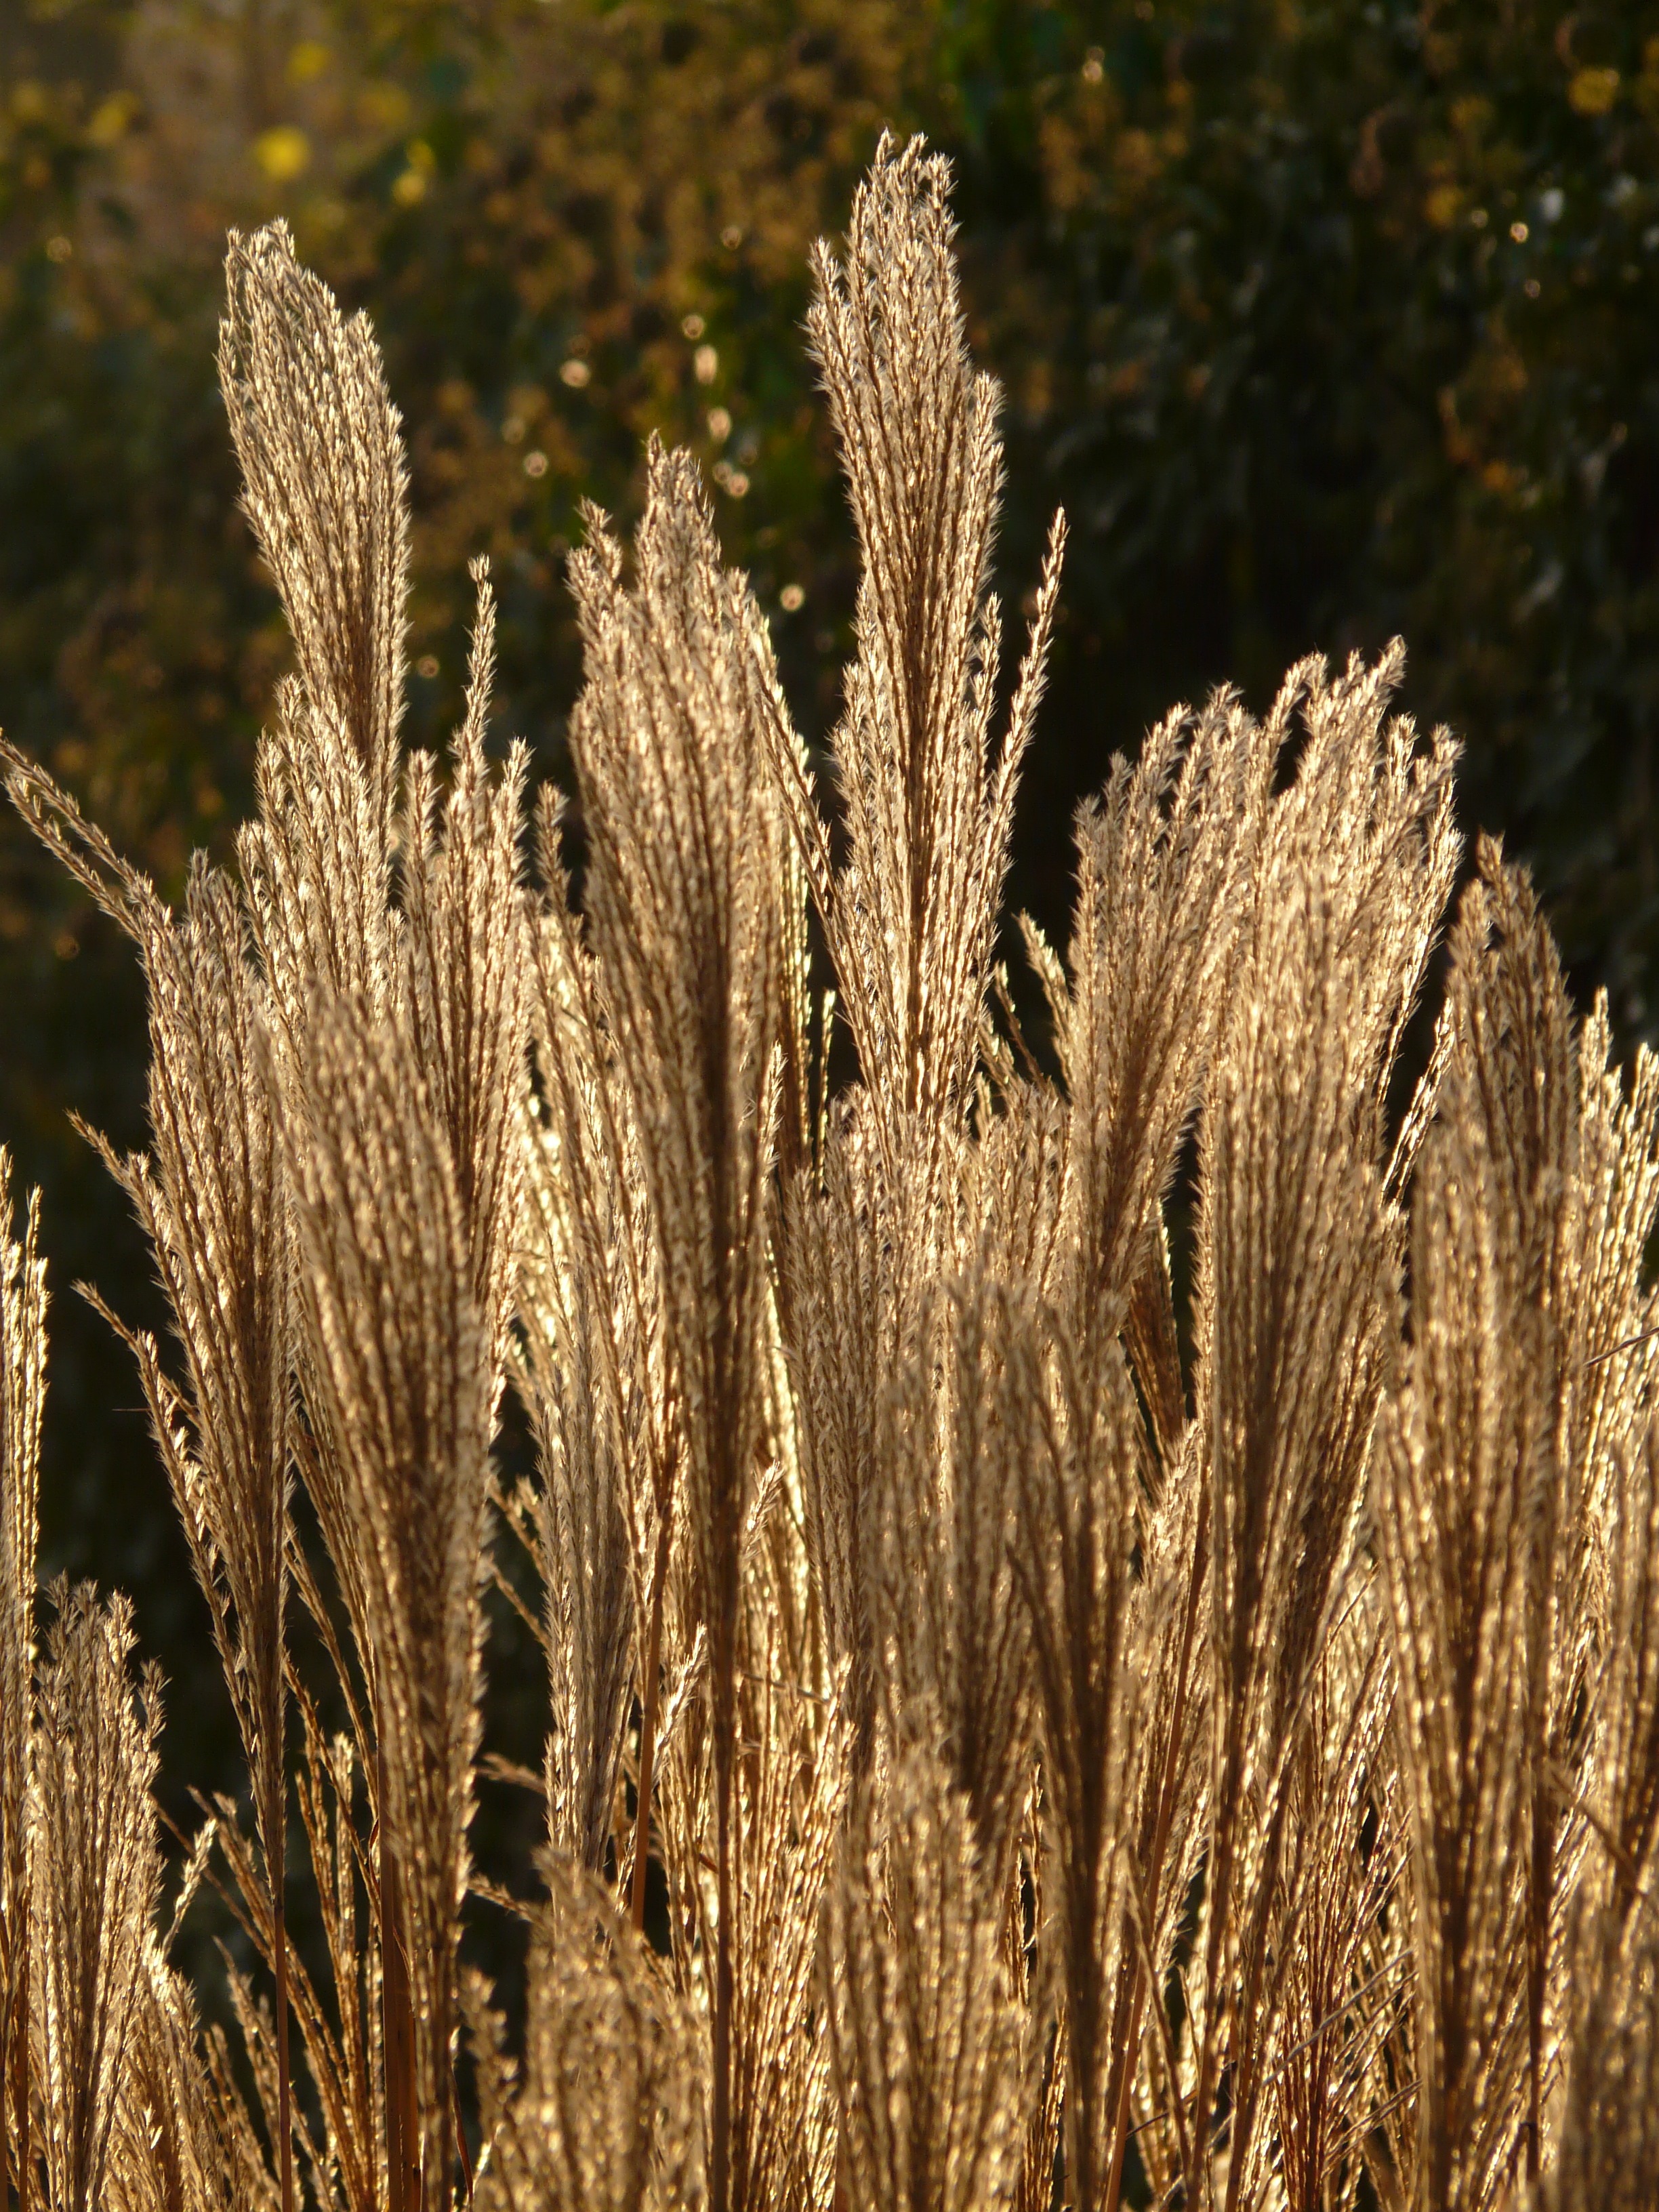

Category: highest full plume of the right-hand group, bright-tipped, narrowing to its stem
[1188, 653, 1458, 2207]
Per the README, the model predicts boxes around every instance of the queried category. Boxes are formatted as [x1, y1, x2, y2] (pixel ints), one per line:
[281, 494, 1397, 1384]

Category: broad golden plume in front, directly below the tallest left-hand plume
[283, 1004, 495, 2207]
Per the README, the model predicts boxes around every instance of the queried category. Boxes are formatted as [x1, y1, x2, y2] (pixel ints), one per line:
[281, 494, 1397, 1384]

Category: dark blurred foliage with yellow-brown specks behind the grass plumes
[0, 0, 1659, 1781]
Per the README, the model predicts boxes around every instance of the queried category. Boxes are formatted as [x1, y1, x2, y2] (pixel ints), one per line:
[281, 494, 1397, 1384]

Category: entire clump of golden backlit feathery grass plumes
[0, 142, 1659, 2212]
